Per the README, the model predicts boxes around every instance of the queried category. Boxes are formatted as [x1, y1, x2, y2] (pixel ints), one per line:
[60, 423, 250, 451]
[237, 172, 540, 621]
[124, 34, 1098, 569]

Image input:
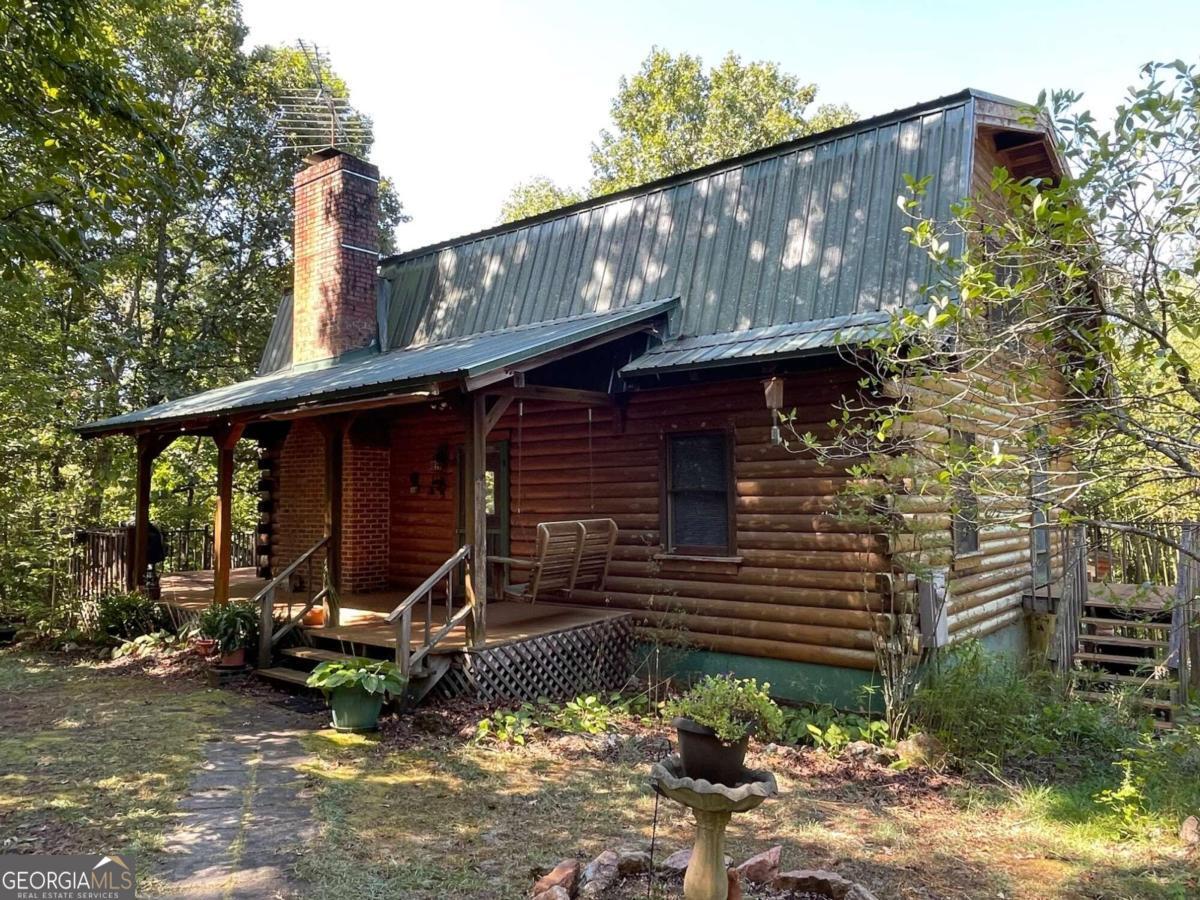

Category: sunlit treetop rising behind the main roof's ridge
[502, 47, 857, 222]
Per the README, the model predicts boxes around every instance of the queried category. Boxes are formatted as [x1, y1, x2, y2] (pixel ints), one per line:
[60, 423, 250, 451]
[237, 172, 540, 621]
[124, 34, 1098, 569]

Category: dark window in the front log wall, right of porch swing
[664, 431, 733, 556]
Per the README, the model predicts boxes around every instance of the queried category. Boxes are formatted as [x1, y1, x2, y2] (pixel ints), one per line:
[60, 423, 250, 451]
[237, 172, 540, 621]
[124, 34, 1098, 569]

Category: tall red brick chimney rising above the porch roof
[292, 148, 379, 365]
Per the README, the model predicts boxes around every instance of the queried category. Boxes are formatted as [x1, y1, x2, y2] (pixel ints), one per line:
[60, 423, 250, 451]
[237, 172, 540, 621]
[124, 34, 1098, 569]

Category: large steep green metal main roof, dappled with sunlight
[382, 91, 984, 344]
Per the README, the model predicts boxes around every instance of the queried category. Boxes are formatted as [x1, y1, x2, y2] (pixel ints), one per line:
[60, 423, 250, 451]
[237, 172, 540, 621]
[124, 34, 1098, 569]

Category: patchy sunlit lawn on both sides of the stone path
[0, 653, 1200, 900]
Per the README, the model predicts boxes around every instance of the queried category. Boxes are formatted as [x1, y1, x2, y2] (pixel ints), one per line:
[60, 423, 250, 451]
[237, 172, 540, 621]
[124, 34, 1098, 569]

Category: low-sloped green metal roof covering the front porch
[79, 299, 677, 436]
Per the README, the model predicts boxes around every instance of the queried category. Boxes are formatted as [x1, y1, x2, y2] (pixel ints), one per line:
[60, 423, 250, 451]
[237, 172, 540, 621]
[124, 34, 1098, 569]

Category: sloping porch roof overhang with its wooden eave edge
[77, 298, 678, 437]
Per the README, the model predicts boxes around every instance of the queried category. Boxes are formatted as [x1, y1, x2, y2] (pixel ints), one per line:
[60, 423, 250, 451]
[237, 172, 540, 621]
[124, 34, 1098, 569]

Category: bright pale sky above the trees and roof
[242, 0, 1200, 250]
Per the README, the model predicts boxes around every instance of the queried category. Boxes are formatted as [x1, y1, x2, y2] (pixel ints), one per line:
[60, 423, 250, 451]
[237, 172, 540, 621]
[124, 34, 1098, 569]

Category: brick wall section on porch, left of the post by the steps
[271, 419, 325, 574]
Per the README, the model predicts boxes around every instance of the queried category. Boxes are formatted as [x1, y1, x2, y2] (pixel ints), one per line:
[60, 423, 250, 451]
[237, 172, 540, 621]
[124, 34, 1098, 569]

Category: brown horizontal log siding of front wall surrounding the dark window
[491, 366, 890, 668]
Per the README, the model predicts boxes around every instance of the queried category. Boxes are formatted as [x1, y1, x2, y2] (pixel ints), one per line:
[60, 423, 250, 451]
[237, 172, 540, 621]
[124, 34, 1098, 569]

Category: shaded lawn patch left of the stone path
[0, 652, 242, 866]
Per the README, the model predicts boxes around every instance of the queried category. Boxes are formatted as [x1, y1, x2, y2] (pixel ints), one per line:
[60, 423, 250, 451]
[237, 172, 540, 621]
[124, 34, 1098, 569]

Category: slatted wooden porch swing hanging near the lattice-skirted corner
[490, 518, 617, 602]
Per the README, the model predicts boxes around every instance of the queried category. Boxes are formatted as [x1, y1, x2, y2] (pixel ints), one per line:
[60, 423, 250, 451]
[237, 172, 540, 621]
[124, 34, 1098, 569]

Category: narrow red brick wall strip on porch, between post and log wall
[342, 437, 391, 600]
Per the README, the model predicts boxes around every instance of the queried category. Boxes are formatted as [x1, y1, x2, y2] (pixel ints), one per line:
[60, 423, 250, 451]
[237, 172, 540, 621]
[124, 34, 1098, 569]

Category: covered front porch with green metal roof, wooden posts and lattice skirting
[77, 301, 672, 697]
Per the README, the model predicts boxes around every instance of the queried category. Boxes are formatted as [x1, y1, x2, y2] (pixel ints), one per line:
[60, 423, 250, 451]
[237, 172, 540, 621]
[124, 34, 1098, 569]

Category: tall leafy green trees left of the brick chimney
[0, 0, 403, 614]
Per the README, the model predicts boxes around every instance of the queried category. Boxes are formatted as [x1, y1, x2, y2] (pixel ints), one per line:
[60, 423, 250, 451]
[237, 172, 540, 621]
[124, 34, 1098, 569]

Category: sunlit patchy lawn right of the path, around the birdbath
[297, 715, 1200, 900]
